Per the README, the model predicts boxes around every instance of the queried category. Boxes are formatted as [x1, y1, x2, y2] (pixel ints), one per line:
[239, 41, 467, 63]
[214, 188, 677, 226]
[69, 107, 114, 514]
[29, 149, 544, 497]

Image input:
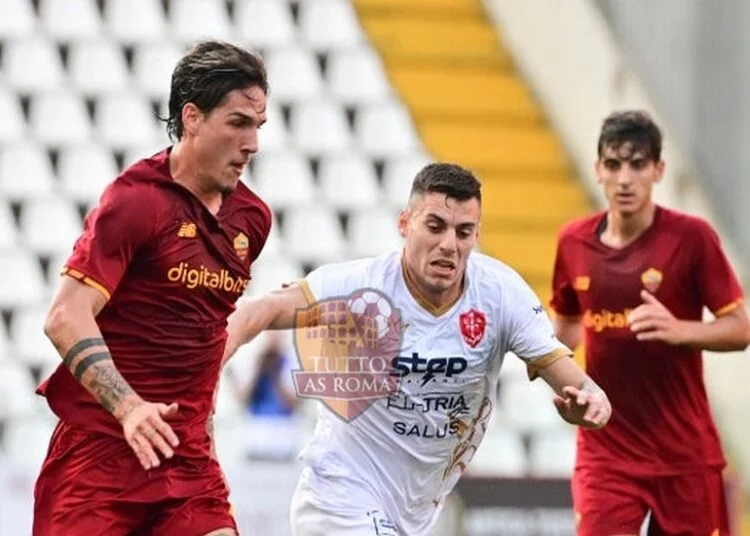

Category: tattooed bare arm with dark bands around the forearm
[44, 277, 178, 469]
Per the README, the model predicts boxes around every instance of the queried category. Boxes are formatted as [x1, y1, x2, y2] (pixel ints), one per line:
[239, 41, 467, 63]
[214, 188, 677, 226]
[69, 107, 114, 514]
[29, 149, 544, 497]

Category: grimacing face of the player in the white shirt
[399, 192, 481, 296]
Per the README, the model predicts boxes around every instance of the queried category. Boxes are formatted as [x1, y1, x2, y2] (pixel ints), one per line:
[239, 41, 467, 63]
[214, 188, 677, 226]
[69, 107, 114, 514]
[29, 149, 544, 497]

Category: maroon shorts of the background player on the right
[572, 462, 730, 536]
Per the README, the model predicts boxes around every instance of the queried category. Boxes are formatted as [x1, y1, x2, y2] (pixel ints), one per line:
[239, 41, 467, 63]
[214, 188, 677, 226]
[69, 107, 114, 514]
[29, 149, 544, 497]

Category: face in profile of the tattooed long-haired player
[194, 86, 266, 193]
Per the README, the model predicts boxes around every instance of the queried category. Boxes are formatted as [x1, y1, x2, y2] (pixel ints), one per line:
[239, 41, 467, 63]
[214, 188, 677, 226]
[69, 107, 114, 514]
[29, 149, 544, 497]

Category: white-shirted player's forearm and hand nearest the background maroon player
[539, 358, 612, 428]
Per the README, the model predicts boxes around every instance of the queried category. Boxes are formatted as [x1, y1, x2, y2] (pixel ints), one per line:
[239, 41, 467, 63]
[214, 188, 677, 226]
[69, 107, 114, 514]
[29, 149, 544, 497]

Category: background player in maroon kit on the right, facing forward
[551, 111, 750, 536]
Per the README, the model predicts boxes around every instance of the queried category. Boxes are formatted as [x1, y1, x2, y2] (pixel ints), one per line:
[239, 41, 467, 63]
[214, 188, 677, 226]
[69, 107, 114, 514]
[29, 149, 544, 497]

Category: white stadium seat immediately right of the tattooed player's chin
[253, 152, 316, 209]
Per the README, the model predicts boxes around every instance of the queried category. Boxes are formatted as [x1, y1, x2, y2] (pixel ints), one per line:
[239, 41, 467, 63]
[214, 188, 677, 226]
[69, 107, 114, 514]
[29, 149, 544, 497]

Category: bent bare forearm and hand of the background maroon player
[628, 290, 750, 352]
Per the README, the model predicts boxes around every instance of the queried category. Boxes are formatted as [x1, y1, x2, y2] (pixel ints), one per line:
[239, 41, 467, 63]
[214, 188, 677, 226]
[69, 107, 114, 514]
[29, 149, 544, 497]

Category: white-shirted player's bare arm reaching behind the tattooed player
[222, 284, 309, 365]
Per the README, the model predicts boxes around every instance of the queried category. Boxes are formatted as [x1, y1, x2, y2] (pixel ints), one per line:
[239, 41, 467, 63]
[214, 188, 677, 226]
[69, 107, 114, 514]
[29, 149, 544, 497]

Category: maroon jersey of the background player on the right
[551, 207, 742, 475]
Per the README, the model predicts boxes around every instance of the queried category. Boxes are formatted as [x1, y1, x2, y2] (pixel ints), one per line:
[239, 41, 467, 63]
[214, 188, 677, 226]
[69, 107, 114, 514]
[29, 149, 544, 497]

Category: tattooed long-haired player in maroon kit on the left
[34, 41, 271, 536]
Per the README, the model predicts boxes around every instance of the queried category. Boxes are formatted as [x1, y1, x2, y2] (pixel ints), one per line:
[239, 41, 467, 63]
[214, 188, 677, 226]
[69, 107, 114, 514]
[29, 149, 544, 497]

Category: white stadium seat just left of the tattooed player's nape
[95, 91, 159, 151]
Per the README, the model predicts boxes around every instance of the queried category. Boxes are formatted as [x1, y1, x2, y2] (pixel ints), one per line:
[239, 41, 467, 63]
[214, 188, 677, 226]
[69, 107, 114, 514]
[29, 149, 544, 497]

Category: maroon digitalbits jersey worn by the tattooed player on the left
[39, 149, 271, 456]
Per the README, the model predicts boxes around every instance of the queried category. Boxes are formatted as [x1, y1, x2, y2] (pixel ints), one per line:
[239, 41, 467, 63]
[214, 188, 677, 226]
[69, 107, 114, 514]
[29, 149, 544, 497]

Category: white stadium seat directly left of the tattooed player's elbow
[10, 305, 60, 368]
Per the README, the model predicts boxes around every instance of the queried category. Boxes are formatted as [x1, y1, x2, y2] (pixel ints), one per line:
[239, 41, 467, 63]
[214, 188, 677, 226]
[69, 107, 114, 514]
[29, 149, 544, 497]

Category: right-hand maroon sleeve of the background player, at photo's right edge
[693, 221, 743, 316]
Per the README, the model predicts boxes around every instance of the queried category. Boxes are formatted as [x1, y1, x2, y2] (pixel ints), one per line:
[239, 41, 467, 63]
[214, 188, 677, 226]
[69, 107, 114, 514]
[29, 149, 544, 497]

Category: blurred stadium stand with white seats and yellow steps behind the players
[0, 0, 750, 536]
